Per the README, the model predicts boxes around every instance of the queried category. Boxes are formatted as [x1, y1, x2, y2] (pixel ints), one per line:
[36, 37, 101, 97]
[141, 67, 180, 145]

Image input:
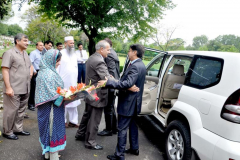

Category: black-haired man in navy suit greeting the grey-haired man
[98, 44, 146, 160]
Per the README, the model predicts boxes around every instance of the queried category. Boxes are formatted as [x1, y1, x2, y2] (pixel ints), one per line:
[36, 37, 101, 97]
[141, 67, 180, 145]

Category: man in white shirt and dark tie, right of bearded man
[76, 43, 88, 83]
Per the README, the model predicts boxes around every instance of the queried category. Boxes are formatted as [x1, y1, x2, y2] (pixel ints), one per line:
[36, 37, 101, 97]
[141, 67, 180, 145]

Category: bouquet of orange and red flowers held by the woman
[56, 82, 105, 101]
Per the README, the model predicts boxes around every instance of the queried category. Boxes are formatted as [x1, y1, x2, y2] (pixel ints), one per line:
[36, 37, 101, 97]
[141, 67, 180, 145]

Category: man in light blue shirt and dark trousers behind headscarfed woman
[28, 42, 44, 111]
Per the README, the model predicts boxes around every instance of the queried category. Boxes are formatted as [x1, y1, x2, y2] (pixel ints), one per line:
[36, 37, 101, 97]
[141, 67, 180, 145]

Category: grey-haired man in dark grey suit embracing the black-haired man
[75, 40, 111, 150]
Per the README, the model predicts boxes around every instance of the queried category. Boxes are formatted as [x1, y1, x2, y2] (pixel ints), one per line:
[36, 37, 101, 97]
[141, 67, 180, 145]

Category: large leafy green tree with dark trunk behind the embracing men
[31, 0, 174, 54]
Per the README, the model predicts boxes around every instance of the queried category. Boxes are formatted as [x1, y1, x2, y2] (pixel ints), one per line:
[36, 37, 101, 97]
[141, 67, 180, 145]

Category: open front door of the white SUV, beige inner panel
[140, 48, 168, 115]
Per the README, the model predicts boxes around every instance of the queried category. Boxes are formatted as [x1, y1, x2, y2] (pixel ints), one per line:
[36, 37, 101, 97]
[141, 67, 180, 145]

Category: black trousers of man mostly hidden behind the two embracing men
[104, 90, 117, 131]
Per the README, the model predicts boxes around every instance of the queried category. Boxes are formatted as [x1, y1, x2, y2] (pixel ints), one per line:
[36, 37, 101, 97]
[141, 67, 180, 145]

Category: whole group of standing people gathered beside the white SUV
[2, 34, 146, 160]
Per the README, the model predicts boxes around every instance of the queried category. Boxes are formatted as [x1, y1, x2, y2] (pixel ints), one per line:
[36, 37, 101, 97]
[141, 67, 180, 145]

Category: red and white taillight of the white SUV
[221, 89, 240, 124]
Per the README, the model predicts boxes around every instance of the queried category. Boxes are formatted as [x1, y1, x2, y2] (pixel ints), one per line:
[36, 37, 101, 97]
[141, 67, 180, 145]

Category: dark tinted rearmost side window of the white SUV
[185, 56, 223, 89]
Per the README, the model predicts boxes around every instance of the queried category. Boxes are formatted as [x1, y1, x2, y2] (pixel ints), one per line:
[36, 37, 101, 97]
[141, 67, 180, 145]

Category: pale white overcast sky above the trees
[8, 0, 240, 45]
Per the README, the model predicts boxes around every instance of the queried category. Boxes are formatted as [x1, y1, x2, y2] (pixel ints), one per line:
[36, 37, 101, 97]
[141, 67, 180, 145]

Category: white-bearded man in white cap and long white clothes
[57, 36, 81, 128]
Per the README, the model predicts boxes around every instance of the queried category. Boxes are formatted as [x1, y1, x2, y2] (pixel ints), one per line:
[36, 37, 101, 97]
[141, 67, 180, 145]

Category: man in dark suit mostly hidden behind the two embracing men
[98, 38, 120, 136]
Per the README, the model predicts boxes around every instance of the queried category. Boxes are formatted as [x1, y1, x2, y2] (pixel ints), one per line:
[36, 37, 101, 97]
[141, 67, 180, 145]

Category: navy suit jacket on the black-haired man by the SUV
[106, 59, 146, 116]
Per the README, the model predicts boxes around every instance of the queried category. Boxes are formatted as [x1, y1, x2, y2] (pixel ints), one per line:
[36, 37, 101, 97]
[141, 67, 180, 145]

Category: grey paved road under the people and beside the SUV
[0, 104, 166, 160]
